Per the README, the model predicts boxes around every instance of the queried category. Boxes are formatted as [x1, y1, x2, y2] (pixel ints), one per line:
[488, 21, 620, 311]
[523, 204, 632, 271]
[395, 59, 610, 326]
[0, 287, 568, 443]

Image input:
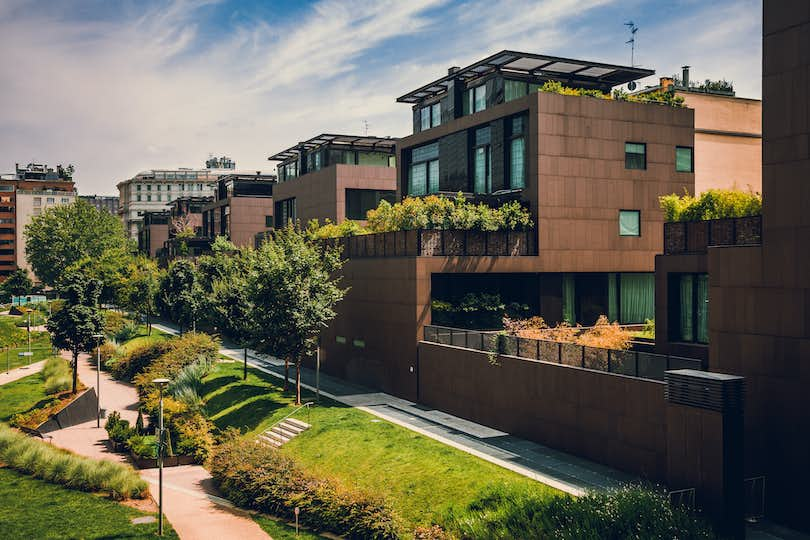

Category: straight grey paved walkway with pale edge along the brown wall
[154, 322, 637, 495]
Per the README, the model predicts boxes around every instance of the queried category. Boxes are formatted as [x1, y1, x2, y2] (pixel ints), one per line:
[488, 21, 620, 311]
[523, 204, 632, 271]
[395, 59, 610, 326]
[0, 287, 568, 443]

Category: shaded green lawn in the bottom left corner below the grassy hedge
[0, 469, 177, 539]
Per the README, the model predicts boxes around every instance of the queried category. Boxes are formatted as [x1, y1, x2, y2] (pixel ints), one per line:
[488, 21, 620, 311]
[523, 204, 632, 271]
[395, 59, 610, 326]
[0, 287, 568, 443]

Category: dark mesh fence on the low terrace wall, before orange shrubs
[424, 325, 703, 381]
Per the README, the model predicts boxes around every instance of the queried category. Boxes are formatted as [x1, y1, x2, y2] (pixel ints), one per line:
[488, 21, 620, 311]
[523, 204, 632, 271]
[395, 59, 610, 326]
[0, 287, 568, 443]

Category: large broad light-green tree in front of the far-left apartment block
[24, 199, 132, 286]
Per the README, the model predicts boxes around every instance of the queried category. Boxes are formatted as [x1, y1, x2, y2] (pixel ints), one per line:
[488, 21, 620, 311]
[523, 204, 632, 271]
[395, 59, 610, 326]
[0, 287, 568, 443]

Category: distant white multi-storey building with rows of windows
[117, 168, 224, 239]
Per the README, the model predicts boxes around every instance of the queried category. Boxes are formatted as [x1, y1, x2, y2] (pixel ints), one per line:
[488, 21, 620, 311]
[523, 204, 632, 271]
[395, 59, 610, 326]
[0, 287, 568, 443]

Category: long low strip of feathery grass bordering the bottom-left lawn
[0, 424, 148, 499]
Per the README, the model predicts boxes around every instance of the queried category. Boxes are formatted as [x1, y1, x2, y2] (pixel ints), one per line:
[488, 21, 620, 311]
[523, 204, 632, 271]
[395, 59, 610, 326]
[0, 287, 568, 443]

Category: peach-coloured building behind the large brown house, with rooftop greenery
[641, 66, 762, 193]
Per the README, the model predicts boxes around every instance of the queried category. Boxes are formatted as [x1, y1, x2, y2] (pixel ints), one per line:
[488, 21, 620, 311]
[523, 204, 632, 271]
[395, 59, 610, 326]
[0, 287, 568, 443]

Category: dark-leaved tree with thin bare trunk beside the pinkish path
[46, 273, 104, 394]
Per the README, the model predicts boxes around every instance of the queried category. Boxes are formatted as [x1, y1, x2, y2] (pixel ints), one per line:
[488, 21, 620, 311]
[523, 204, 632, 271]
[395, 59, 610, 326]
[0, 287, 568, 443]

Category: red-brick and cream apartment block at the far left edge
[0, 163, 76, 279]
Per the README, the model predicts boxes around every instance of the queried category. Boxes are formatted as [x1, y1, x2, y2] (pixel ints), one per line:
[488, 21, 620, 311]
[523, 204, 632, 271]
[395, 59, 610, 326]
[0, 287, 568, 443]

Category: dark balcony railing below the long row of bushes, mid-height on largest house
[327, 229, 537, 258]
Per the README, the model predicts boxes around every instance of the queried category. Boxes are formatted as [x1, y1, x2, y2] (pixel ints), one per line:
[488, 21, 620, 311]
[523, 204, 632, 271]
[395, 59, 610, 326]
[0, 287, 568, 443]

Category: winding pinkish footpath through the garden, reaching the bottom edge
[50, 354, 269, 540]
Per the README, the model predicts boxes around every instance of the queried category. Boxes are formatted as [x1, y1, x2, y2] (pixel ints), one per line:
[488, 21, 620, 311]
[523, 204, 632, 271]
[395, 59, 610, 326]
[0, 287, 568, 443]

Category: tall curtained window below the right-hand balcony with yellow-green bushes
[669, 274, 709, 343]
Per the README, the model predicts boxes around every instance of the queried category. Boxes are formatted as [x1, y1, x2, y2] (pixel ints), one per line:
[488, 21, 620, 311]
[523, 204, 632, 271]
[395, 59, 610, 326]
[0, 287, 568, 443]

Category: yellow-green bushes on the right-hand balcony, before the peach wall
[658, 189, 762, 221]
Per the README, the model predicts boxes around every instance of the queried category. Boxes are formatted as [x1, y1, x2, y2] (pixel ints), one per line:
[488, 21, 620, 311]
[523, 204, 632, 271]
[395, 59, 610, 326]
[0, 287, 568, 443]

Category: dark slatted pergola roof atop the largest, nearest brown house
[397, 51, 655, 103]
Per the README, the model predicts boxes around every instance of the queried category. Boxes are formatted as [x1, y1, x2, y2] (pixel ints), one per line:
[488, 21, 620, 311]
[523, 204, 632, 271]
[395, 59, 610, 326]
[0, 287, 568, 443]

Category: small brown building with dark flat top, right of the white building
[202, 171, 276, 246]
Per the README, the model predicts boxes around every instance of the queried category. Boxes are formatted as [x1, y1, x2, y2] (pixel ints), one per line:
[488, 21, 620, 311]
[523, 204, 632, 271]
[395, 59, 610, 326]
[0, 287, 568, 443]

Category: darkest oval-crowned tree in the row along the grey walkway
[159, 259, 202, 331]
